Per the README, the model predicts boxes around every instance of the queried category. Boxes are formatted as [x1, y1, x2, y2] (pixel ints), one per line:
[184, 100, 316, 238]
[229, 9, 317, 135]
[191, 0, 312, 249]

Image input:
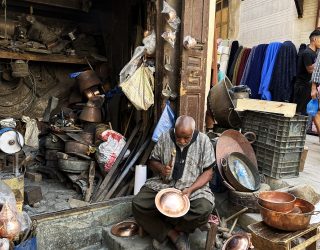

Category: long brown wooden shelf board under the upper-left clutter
[0, 50, 87, 64]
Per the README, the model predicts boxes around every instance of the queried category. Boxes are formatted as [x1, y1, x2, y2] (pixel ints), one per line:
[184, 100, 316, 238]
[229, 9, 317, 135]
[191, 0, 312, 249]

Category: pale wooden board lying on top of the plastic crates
[235, 99, 297, 117]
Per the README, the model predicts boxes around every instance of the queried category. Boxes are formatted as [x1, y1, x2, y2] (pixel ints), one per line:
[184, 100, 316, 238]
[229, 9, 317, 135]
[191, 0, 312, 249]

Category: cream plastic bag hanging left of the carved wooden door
[120, 65, 154, 110]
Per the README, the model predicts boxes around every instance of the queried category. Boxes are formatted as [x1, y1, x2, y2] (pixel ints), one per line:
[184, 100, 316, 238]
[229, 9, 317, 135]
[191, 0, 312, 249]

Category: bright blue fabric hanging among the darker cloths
[259, 42, 282, 101]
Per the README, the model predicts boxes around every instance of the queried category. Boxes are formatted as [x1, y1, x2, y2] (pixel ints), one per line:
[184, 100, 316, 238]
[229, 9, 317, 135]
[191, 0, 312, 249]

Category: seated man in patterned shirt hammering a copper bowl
[132, 116, 215, 250]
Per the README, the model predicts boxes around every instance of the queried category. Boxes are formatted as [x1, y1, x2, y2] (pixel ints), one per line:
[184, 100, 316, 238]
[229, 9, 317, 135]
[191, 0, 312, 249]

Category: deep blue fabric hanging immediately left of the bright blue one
[242, 44, 268, 99]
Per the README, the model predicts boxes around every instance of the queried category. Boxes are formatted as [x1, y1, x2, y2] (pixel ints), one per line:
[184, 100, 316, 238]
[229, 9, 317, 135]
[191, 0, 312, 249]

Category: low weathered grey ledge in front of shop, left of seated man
[32, 196, 132, 250]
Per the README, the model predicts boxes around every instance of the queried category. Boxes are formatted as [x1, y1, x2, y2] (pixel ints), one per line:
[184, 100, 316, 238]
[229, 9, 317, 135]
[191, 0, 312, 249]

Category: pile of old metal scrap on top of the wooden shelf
[0, 15, 98, 56]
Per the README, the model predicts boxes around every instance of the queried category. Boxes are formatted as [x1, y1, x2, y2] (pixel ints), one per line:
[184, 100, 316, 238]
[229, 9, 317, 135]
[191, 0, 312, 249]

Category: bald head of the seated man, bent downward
[175, 115, 196, 147]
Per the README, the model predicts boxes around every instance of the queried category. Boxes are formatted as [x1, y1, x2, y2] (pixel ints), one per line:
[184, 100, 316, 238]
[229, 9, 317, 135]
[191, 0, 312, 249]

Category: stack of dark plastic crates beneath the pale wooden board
[242, 111, 308, 179]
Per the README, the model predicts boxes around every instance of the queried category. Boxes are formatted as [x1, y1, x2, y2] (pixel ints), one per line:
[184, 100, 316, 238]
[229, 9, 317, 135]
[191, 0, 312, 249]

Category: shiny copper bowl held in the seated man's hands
[155, 188, 190, 218]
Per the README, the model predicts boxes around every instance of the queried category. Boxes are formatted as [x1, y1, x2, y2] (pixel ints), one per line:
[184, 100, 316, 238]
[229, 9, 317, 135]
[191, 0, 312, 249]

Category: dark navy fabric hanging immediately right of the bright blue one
[269, 41, 297, 102]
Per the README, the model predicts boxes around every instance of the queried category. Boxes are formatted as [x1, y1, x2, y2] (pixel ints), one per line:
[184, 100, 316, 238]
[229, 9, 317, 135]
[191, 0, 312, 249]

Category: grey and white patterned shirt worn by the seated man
[145, 131, 215, 204]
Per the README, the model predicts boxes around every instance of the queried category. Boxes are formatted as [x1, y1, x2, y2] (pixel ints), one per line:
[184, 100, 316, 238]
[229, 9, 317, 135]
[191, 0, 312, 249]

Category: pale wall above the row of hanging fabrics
[237, 0, 318, 47]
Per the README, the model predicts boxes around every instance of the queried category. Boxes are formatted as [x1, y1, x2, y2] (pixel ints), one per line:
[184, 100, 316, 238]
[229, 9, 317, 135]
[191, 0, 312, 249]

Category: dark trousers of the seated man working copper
[132, 187, 213, 242]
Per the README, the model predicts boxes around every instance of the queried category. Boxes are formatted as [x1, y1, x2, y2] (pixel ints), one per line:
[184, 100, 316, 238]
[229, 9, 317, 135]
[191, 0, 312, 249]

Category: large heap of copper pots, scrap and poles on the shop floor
[37, 70, 152, 201]
